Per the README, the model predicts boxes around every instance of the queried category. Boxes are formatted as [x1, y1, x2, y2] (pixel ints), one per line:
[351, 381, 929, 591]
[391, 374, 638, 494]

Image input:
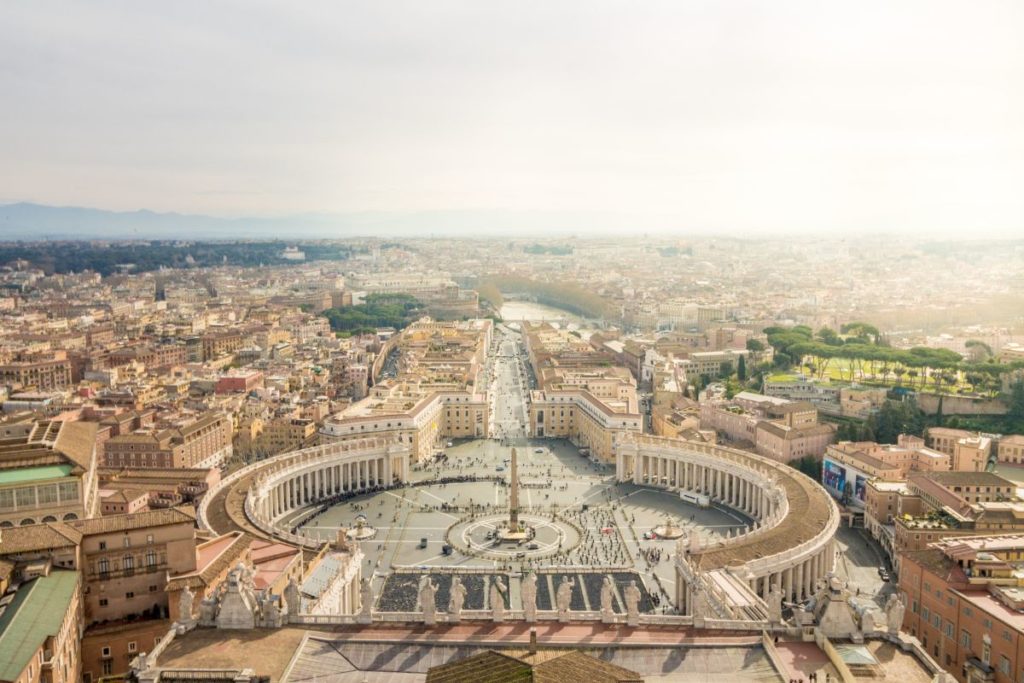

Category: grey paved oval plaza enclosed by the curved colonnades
[291, 439, 750, 604]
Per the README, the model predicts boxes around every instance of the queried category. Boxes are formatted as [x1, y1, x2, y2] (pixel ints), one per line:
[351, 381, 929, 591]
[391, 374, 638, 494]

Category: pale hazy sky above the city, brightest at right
[0, 0, 1024, 237]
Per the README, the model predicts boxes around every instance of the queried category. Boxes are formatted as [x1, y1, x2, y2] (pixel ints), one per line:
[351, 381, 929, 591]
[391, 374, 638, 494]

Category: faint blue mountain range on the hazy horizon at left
[0, 203, 637, 241]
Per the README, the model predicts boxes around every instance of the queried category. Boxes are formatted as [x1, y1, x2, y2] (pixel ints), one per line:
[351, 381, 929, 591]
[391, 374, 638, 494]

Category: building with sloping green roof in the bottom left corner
[0, 562, 82, 683]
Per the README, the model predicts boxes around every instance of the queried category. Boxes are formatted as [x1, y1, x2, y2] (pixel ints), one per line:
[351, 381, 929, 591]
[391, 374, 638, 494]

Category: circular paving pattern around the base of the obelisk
[444, 513, 582, 560]
